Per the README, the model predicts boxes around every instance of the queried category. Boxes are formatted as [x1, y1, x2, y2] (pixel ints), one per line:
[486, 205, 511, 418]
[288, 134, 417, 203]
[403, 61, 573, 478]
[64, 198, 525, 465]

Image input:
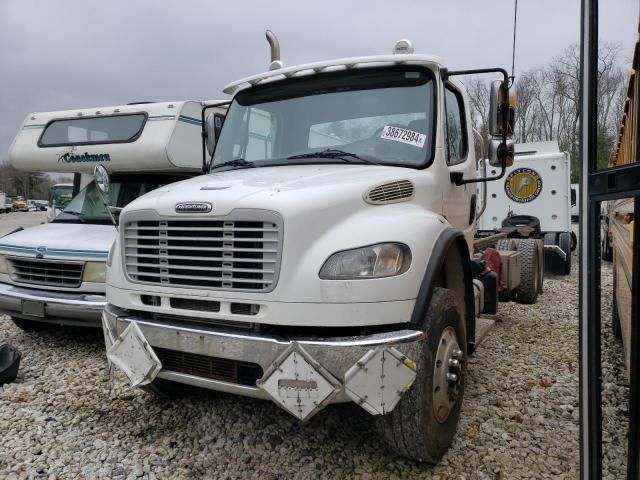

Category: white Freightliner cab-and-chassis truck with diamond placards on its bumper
[102, 32, 542, 462]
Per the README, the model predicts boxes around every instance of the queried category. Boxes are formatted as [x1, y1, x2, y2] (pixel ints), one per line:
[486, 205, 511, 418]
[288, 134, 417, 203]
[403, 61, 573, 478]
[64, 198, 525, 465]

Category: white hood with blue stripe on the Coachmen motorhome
[0, 223, 116, 260]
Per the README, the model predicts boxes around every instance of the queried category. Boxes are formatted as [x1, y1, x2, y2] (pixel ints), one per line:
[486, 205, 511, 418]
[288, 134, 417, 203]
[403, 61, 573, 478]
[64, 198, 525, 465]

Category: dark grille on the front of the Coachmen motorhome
[7, 257, 84, 288]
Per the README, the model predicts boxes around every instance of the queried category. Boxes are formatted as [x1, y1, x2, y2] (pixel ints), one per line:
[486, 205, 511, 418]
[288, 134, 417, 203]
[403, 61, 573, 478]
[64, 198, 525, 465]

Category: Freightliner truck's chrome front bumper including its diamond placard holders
[102, 304, 426, 420]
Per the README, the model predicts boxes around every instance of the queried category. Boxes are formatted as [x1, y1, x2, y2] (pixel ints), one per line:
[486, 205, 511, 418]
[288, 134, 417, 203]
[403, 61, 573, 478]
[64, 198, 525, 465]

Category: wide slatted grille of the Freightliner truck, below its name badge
[124, 214, 281, 291]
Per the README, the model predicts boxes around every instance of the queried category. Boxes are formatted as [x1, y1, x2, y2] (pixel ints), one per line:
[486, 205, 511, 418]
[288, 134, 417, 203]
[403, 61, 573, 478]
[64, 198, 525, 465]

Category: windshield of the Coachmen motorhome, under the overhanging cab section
[54, 174, 186, 224]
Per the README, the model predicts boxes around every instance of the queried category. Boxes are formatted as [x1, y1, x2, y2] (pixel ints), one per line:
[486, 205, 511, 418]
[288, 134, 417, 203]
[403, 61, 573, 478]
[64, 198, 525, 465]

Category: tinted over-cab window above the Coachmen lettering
[38, 113, 147, 147]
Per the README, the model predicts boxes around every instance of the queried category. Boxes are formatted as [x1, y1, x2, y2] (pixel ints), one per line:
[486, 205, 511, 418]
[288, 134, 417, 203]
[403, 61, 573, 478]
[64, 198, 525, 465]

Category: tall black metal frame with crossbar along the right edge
[579, 0, 640, 480]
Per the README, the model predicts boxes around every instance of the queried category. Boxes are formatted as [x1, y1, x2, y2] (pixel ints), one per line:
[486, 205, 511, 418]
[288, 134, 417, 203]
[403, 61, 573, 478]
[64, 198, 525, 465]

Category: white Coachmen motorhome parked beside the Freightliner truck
[0, 102, 224, 331]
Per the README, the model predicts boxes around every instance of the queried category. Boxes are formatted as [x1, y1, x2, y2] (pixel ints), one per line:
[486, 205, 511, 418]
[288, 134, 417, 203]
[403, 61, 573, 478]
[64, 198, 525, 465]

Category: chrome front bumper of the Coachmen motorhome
[0, 283, 107, 328]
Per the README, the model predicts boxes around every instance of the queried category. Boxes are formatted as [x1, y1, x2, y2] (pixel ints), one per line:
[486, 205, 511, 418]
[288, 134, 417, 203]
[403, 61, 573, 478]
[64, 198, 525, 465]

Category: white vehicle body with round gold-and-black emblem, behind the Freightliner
[478, 141, 576, 274]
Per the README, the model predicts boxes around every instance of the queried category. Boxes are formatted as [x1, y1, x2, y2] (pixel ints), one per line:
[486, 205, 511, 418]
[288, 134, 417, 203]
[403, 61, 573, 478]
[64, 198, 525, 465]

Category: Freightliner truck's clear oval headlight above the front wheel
[319, 243, 411, 280]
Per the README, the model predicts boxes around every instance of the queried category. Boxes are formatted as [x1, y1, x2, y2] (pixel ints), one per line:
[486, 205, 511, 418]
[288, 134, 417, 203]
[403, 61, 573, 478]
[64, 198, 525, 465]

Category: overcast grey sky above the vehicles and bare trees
[0, 0, 640, 161]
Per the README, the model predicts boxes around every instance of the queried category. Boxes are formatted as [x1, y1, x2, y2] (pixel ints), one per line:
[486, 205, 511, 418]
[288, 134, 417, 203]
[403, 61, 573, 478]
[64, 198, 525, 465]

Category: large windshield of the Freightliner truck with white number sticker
[212, 66, 435, 169]
